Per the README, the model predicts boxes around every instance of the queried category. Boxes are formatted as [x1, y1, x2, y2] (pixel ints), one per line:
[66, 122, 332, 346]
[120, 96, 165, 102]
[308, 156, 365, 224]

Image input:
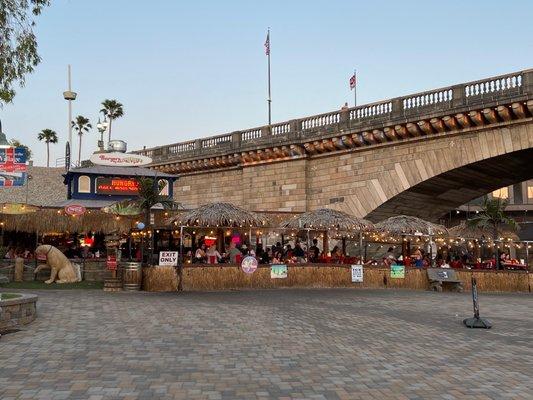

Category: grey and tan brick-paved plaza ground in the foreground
[0, 289, 533, 400]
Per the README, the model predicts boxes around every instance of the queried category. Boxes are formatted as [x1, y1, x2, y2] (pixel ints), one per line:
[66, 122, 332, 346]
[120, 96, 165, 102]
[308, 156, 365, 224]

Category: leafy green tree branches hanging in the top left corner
[0, 0, 50, 106]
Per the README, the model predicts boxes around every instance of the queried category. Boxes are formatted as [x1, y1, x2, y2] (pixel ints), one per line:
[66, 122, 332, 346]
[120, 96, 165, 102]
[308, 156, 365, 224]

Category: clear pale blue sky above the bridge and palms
[0, 0, 533, 165]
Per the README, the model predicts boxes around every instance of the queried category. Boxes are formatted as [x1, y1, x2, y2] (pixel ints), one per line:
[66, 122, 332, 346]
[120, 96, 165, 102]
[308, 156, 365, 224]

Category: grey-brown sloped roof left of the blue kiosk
[0, 166, 67, 207]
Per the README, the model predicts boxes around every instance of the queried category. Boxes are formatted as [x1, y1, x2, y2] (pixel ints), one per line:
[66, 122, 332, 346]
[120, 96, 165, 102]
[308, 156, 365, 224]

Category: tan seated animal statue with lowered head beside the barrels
[34, 244, 81, 283]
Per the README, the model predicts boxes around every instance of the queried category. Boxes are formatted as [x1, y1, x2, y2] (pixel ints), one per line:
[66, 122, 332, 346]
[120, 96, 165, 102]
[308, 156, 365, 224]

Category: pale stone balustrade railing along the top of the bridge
[134, 69, 533, 163]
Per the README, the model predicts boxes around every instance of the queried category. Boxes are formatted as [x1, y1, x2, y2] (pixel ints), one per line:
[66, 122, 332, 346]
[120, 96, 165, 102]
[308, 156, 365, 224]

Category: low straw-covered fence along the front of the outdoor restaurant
[143, 264, 533, 292]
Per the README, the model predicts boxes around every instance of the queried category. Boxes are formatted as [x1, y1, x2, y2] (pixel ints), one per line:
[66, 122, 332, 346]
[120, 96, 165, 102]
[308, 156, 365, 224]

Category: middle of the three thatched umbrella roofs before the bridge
[280, 208, 374, 231]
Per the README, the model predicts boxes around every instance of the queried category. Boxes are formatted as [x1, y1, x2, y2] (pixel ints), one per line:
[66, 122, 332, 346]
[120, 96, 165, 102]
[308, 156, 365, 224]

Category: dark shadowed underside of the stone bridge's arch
[366, 148, 533, 222]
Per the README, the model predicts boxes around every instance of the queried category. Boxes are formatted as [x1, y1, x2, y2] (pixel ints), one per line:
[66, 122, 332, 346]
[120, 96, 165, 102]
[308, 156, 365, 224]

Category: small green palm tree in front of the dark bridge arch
[467, 196, 518, 269]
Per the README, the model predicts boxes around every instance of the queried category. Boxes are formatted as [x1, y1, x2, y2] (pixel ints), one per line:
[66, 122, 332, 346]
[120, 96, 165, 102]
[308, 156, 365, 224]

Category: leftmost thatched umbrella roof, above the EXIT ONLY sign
[167, 203, 267, 228]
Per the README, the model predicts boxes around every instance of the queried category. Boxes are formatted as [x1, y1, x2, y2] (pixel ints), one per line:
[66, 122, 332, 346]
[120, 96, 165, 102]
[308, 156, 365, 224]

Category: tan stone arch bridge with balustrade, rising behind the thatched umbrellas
[137, 69, 533, 220]
